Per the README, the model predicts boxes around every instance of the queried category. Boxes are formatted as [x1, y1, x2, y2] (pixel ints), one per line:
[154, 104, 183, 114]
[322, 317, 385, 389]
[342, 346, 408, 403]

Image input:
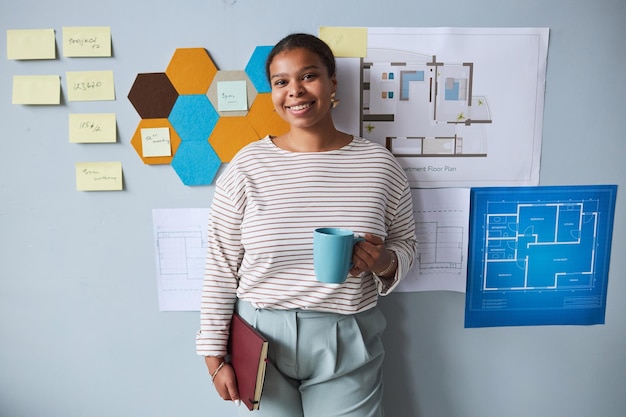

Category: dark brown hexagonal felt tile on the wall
[128, 72, 178, 119]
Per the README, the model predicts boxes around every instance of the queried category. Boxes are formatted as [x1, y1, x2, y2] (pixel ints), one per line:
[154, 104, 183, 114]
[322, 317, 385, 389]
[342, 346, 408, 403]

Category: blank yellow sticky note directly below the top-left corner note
[12, 75, 61, 104]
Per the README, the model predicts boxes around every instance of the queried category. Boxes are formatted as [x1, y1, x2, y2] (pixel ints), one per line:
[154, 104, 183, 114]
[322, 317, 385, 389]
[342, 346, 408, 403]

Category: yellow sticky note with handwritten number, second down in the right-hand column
[65, 71, 115, 101]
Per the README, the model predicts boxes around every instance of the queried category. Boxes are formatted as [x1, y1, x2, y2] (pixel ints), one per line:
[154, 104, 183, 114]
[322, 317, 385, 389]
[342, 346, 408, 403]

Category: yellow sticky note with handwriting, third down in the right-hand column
[69, 113, 117, 143]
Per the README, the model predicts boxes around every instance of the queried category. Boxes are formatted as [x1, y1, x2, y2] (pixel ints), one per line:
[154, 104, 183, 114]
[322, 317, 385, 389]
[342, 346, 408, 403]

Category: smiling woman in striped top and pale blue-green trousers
[197, 34, 416, 417]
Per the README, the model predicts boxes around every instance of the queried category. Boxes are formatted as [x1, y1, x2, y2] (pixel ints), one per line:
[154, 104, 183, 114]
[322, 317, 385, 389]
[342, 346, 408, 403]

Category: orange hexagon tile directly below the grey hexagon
[209, 116, 259, 162]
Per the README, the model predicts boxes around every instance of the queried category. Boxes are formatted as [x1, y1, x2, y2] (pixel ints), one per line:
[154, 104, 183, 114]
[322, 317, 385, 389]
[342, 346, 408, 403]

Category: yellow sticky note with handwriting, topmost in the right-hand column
[63, 26, 111, 57]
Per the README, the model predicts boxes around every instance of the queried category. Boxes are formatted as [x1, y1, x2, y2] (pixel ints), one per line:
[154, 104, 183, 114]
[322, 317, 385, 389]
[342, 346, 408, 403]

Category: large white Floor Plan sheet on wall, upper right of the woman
[346, 28, 549, 188]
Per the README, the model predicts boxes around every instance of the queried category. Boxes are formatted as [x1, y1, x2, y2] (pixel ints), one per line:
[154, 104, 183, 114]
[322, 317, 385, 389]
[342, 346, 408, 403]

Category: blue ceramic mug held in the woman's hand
[313, 227, 365, 284]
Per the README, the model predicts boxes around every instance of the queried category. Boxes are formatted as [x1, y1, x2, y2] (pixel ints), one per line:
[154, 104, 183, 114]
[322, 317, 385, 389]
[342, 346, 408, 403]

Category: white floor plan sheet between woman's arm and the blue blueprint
[395, 188, 470, 292]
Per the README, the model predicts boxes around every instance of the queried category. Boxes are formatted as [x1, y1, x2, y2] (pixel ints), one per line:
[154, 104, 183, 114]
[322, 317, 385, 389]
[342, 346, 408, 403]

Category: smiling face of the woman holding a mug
[269, 48, 337, 128]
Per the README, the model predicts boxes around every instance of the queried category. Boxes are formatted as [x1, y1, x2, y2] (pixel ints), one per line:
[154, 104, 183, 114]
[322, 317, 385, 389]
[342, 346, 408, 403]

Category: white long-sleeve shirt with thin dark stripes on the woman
[196, 137, 417, 356]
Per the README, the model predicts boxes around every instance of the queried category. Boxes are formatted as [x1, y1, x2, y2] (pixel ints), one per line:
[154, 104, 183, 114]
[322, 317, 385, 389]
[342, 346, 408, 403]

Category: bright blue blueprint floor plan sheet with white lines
[465, 185, 617, 327]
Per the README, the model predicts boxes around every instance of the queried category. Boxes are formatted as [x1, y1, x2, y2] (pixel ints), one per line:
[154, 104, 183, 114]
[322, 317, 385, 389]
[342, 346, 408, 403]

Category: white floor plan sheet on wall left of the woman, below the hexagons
[152, 208, 209, 311]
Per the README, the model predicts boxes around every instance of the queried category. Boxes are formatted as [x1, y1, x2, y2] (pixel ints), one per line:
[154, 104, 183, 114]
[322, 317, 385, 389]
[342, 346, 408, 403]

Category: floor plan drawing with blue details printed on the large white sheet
[361, 49, 491, 157]
